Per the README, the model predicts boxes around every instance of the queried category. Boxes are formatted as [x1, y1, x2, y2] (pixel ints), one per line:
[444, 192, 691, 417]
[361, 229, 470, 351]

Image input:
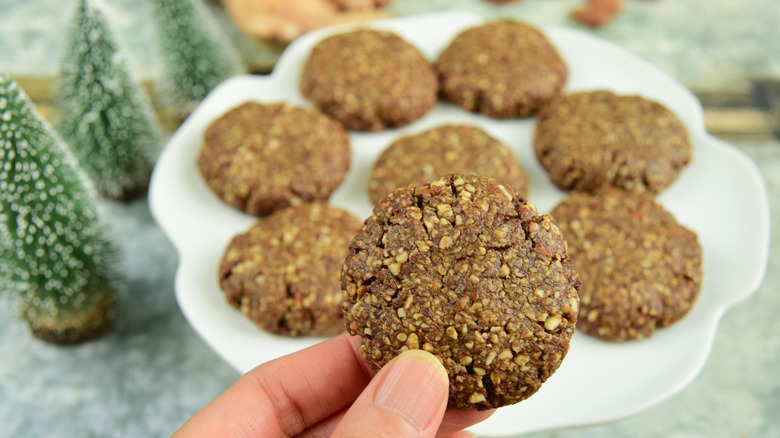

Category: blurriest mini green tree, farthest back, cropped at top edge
[152, 0, 246, 116]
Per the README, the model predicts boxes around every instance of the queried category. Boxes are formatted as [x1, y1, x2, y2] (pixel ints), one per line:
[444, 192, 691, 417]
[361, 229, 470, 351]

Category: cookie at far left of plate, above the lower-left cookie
[197, 101, 350, 216]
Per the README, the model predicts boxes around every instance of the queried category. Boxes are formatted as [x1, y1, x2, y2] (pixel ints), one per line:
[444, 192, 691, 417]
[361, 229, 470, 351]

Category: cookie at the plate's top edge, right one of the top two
[436, 20, 568, 119]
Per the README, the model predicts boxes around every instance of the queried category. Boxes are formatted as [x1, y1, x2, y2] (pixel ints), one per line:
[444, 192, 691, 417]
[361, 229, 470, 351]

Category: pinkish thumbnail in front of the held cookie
[374, 350, 449, 430]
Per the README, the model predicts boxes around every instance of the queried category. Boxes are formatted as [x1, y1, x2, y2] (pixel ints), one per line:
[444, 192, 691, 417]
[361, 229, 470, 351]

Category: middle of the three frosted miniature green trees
[55, 0, 161, 201]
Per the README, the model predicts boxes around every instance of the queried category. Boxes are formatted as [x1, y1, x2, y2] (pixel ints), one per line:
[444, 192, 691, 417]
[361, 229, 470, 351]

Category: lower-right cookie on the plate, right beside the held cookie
[552, 188, 702, 341]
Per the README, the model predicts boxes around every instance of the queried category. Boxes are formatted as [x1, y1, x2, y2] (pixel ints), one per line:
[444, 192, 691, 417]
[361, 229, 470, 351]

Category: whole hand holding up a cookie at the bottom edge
[174, 334, 493, 438]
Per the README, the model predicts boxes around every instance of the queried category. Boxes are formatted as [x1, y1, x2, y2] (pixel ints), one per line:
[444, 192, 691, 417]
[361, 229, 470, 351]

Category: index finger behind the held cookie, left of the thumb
[174, 334, 371, 437]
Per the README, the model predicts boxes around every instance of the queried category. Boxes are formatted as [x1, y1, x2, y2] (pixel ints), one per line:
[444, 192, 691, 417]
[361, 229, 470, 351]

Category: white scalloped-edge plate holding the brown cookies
[150, 12, 769, 436]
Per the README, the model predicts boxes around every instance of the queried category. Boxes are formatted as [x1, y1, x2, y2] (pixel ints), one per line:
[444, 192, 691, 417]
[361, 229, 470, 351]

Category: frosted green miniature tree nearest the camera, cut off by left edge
[0, 74, 116, 344]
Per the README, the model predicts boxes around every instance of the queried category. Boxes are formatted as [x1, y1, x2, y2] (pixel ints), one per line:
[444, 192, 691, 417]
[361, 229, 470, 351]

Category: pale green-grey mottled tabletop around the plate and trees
[0, 0, 780, 438]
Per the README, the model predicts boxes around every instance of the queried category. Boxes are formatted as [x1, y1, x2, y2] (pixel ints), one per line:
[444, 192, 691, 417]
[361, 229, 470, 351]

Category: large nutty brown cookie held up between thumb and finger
[341, 175, 579, 409]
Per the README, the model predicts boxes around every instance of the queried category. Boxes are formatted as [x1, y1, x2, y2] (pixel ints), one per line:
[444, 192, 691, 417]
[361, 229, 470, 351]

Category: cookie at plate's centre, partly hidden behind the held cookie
[368, 125, 528, 204]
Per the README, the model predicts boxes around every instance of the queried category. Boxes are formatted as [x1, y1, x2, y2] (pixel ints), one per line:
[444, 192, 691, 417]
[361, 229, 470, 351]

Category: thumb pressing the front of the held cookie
[333, 350, 449, 438]
